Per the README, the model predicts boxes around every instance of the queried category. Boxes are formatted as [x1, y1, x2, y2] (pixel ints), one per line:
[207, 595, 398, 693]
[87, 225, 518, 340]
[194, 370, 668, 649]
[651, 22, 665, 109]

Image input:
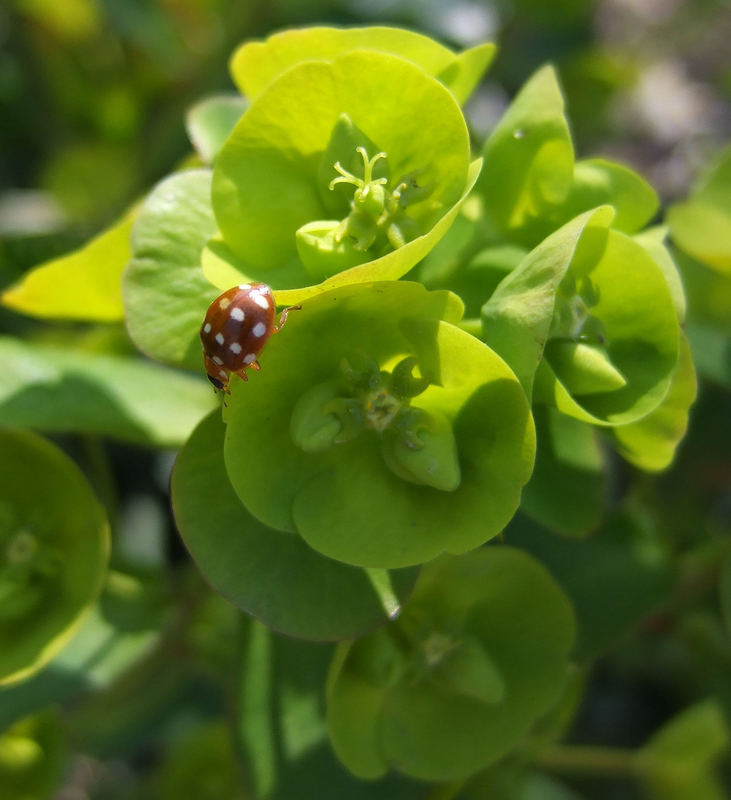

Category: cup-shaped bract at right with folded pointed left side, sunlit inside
[482, 207, 680, 425]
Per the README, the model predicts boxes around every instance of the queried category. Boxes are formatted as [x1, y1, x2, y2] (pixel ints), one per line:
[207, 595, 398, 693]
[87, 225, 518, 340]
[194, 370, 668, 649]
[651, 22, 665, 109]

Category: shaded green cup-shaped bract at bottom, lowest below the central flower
[327, 546, 574, 781]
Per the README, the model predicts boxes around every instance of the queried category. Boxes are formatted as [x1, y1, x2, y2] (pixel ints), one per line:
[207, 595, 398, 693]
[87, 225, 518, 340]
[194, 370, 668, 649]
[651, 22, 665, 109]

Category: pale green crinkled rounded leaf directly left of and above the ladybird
[123, 169, 220, 370]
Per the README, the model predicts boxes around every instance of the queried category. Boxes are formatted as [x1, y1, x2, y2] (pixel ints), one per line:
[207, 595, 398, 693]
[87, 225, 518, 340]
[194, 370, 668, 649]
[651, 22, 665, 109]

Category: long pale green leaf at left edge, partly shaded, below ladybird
[0, 336, 215, 447]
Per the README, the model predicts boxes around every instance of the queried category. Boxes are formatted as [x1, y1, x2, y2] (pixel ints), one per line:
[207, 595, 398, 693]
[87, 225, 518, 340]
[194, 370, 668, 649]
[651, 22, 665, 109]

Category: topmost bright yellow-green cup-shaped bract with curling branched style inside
[209, 50, 479, 303]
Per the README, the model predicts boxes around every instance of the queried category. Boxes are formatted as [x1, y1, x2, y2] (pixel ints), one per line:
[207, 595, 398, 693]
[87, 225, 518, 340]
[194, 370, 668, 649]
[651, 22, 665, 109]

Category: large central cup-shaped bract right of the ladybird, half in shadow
[224, 281, 535, 568]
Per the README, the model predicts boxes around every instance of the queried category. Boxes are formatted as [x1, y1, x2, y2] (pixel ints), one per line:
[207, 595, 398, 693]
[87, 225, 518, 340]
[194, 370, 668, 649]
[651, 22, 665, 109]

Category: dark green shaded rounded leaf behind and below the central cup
[171, 412, 417, 639]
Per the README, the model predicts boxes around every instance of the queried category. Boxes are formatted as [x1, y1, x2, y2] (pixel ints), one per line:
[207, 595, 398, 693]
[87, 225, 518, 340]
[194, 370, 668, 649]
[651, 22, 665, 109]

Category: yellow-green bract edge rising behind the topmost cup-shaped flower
[230, 26, 495, 103]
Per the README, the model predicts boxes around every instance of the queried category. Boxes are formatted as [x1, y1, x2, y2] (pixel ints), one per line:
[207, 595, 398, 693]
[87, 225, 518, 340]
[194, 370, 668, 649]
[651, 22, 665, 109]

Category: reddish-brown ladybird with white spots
[201, 283, 301, 394]
